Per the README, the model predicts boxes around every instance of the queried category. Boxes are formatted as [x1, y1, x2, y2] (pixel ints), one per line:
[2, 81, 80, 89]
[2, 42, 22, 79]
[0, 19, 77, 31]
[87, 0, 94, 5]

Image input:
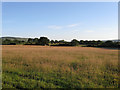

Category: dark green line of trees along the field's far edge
[2, 37, 120, 48]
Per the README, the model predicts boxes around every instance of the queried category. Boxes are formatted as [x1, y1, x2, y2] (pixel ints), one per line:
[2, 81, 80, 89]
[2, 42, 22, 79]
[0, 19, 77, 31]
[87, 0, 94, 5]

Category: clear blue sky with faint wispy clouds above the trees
[2, 2, 118, 41]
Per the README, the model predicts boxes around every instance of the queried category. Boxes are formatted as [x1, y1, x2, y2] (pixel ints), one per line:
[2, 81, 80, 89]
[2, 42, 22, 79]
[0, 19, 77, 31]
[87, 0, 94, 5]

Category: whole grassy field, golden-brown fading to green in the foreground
[2, 45, 119, 89]
